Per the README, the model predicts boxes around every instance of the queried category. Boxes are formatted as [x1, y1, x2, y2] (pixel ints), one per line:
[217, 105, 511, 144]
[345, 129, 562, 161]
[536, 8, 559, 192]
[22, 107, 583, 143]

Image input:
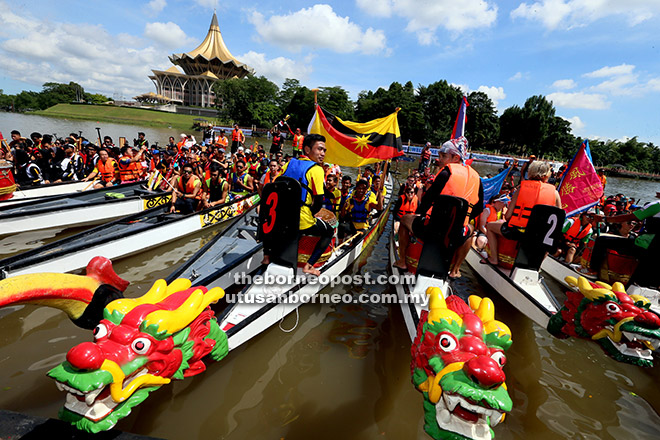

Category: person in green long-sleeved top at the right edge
[590, 193, 660, 289]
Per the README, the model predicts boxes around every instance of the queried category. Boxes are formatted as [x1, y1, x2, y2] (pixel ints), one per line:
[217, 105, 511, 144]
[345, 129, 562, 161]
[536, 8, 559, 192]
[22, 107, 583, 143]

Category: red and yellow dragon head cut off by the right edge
[548, 277, 660, 367]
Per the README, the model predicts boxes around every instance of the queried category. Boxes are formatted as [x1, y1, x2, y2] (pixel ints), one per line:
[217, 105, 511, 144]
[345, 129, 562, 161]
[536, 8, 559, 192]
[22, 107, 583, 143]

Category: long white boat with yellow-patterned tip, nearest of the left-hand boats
[0, 194, 259, 279]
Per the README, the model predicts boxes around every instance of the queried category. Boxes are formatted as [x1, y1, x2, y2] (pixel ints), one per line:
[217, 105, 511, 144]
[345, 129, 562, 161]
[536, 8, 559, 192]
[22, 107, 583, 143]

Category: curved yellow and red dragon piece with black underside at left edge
[0, 257, 128, 329]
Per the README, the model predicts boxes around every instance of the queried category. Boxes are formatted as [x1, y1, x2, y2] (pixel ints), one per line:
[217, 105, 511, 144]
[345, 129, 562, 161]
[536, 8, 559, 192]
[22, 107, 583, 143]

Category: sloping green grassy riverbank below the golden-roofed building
[34, 104, 214, 131]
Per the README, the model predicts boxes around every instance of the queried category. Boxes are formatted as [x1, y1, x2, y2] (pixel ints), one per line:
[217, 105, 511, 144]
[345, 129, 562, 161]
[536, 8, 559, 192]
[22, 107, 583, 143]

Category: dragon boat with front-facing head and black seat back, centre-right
[389, 195, 513, 440]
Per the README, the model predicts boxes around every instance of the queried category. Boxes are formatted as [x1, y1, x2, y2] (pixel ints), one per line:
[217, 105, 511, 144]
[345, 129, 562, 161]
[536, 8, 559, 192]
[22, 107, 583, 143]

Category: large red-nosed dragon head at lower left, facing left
[48, 279, 228, 433]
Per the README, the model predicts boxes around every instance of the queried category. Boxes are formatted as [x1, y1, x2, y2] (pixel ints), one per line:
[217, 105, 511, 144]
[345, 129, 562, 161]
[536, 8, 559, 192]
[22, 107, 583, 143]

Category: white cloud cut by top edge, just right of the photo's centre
[357, 0, 497, 45]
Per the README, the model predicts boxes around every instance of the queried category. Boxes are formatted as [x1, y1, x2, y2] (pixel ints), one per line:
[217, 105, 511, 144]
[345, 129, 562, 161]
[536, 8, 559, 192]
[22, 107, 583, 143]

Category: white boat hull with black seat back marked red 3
[219, 174, 392, 349]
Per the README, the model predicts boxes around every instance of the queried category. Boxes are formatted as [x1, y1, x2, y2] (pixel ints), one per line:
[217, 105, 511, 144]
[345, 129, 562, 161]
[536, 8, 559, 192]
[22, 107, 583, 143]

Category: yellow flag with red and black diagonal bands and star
[307, 105, 403, 167]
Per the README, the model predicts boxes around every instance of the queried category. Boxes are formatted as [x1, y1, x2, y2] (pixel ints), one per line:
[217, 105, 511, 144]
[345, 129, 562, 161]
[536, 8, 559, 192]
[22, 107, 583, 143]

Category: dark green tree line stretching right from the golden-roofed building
[214, 76, 660, 174]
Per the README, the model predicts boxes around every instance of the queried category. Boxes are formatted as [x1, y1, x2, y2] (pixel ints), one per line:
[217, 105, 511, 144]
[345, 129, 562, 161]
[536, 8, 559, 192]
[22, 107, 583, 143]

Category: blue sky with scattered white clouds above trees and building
[0, 0, 660, 145]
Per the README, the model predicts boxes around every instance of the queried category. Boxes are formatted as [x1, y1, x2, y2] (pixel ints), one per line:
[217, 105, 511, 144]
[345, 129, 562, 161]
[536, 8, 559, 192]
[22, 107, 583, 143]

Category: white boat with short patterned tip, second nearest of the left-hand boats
[0, 182, 171, 235]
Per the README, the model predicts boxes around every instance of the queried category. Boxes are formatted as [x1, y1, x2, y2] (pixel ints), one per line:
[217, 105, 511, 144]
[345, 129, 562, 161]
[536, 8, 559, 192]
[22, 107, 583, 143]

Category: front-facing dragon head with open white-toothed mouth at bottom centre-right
[411, 287, 513, 440]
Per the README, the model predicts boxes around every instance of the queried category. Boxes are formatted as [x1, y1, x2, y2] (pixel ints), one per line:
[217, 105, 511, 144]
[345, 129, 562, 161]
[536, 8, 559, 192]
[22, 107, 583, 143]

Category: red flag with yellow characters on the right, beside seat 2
[559, 140, 603, 217]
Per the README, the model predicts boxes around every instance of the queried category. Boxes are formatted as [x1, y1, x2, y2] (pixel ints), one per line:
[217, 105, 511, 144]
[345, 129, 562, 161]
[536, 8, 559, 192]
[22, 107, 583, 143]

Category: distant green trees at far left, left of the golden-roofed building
[0, 82, 111, 112]
